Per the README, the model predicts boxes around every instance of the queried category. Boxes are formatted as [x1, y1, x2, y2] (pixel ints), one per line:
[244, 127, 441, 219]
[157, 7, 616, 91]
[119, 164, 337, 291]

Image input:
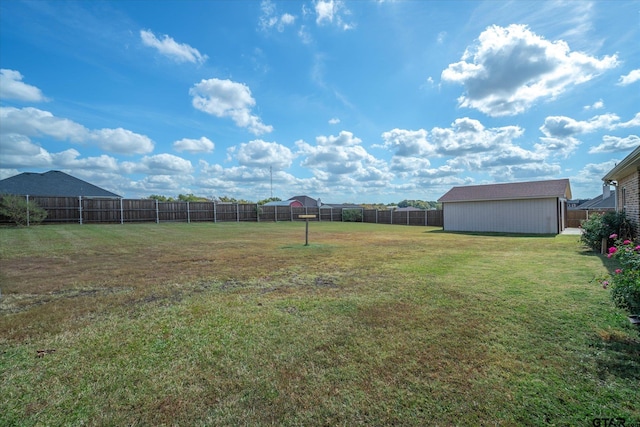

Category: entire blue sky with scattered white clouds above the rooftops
[0, 0, 640, 203]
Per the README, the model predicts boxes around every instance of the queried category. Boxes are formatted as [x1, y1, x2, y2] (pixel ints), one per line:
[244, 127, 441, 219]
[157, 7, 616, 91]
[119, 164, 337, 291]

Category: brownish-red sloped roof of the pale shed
[438, 179, 571, 203]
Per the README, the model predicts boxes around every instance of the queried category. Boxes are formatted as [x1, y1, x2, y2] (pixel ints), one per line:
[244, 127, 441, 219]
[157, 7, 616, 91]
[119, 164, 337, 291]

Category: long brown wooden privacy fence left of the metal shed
[0, 196, 443, 227]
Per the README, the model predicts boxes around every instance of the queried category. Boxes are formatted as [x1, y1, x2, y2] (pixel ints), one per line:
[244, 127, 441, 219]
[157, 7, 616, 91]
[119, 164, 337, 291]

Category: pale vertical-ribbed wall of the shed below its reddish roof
[443, 198, 562, 234]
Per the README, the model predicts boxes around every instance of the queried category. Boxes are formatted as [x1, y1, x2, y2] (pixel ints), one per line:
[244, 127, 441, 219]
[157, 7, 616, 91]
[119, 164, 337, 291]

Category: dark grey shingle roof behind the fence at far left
[0, 171, 121, 199]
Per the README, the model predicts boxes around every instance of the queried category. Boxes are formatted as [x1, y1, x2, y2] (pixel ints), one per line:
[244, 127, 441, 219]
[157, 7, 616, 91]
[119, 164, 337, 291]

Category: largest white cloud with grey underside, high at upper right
[441, 24, 618, 117]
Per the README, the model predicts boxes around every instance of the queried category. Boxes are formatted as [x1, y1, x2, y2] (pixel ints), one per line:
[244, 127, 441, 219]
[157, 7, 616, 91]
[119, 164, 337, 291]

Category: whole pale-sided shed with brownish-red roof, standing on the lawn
[438, 179, 571, 234]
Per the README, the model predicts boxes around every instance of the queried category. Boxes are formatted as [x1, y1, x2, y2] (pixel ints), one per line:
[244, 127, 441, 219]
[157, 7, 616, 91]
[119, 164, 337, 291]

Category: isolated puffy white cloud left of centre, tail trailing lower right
[189, 78, 273, 135]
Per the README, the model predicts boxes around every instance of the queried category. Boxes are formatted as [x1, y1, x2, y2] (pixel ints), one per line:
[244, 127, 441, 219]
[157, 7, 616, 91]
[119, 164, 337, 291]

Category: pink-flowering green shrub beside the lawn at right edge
[602, 234, 640, 314]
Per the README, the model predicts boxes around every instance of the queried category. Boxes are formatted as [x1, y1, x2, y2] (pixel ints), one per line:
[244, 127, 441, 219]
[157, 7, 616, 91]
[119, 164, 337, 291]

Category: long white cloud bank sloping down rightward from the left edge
[0, 107, 153, 154]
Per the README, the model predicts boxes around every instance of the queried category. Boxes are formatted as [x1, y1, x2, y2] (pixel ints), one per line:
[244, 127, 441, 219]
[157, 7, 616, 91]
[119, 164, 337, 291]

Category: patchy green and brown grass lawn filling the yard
[0, 222, 640, 426]
